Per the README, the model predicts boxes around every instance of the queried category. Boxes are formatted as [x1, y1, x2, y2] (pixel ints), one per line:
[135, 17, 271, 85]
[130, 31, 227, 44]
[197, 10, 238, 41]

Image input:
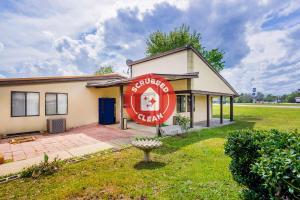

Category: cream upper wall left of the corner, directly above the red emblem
[132, 51, 187, 77]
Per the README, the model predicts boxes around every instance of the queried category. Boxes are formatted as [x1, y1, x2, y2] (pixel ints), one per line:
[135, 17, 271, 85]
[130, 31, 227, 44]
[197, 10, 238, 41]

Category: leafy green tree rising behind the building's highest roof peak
[146, 24, 225, 71]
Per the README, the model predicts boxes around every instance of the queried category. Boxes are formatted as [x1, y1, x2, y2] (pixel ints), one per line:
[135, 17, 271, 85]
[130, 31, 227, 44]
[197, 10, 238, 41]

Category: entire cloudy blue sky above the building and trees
[0, 0, 300, 94]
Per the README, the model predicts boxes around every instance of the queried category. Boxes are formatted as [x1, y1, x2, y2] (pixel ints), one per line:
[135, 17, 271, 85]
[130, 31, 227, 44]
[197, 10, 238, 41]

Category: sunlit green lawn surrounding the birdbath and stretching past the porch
[0, 106, 300, 199]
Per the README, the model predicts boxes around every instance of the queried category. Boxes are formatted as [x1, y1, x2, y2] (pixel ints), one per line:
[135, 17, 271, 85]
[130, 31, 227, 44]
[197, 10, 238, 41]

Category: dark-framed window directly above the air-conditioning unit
[46, 93, 68, 115]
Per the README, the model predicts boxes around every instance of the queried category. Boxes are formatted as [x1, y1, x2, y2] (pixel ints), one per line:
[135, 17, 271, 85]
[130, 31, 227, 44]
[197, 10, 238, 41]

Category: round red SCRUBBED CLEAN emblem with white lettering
[125, 74, 176, 126]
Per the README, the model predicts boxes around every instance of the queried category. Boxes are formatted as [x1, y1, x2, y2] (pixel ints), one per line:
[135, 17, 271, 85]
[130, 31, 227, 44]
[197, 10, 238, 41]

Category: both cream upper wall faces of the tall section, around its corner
[132, 49, 234, 94]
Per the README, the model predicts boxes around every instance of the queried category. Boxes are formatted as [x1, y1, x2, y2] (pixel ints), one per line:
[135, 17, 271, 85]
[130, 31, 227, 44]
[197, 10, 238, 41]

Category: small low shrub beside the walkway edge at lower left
[21, 154, 61, 178]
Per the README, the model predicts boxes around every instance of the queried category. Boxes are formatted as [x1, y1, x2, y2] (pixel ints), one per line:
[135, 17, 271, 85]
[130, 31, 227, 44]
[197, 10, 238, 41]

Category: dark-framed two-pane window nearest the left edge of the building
[11, 92, 40, 117]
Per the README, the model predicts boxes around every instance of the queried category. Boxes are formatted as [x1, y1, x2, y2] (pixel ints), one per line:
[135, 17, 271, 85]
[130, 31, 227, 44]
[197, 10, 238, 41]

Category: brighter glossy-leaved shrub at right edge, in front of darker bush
[252, 130, 300, 199]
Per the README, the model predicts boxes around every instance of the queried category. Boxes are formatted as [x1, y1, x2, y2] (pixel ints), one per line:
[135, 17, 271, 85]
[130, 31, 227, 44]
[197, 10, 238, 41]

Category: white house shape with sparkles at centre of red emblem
[141, 87, 159, 111]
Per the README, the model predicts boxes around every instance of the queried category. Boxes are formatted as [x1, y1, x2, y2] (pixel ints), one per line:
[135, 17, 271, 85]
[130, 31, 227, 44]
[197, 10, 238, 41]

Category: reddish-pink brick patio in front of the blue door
[0, 124, 154, 161]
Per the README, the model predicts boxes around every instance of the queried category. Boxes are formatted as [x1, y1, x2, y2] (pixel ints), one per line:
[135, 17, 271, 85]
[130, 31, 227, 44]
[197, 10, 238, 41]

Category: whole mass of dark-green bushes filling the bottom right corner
[225, 130, 300, 199]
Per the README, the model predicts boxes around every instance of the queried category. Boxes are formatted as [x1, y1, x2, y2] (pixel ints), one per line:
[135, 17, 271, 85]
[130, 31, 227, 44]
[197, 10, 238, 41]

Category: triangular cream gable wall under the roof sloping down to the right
[188, 50, 234, 94]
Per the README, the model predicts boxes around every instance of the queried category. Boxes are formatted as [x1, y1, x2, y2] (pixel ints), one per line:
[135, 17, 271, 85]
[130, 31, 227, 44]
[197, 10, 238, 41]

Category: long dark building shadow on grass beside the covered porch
[153, 119, 255, 155]
